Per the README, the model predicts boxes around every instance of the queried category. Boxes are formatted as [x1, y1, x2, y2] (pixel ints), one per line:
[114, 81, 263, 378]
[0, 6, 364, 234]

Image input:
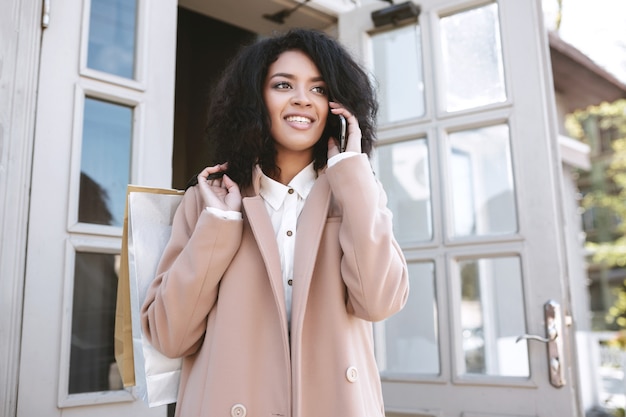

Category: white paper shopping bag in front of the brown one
[114, 186, 183, 407]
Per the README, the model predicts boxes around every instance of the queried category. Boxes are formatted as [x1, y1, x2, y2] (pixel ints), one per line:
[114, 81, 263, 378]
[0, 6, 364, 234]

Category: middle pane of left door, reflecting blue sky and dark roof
[78, 98, 133, 226]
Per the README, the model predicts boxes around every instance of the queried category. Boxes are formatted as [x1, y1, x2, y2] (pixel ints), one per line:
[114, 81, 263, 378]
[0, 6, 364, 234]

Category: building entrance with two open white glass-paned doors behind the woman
[0, 0, 604, 417]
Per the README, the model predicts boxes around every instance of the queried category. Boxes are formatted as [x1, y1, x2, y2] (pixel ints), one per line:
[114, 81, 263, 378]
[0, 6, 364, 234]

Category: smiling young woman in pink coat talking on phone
[142, 30, 408, 417]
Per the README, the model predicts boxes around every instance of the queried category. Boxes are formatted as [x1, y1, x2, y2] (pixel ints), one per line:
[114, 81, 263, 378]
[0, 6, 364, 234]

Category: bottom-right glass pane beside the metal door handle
[458, 257, 529, 376]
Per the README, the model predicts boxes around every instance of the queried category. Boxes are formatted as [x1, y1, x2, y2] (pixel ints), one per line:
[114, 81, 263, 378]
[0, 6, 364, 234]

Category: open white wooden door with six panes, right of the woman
[339, 0, 581, 417]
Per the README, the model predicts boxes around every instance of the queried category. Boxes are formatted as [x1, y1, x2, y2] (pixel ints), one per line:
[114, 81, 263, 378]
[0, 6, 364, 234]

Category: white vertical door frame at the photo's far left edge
[0, 0, 42, 416]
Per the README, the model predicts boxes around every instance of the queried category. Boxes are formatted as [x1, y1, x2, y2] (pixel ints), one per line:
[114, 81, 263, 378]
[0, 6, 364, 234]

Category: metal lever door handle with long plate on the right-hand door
[515, 300, 565, 388]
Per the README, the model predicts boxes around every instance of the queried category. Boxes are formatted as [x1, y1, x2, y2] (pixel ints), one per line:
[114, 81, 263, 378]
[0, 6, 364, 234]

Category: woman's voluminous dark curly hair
[207, 29, 378, 188]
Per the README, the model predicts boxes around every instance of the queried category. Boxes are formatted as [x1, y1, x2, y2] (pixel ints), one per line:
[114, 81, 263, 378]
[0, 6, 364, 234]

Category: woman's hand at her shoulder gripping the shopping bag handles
[198, 164, 241, 212]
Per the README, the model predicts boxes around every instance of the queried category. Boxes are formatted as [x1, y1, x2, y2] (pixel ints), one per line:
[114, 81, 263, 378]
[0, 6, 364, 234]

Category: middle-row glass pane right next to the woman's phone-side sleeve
[376, 139, 432, 244]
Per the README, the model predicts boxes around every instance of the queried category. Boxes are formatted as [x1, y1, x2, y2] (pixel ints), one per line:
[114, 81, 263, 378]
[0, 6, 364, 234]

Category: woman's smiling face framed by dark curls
[263, 50, 329, 169]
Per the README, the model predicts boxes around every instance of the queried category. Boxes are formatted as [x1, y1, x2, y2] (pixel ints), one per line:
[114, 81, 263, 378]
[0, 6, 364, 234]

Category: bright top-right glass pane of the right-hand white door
[441, 3, 506, 111]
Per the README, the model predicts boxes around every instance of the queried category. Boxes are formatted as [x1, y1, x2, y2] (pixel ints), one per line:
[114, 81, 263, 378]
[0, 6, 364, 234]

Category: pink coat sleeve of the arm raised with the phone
[326, 154, 409, 321]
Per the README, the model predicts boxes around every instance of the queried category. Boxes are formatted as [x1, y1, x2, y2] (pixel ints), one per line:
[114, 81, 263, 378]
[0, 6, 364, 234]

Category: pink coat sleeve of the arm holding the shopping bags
[141, 187, 243, 357]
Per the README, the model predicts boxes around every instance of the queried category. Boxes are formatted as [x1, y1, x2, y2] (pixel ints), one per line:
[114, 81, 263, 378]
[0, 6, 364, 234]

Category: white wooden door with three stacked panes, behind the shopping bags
[17, 0, 177, 417]
